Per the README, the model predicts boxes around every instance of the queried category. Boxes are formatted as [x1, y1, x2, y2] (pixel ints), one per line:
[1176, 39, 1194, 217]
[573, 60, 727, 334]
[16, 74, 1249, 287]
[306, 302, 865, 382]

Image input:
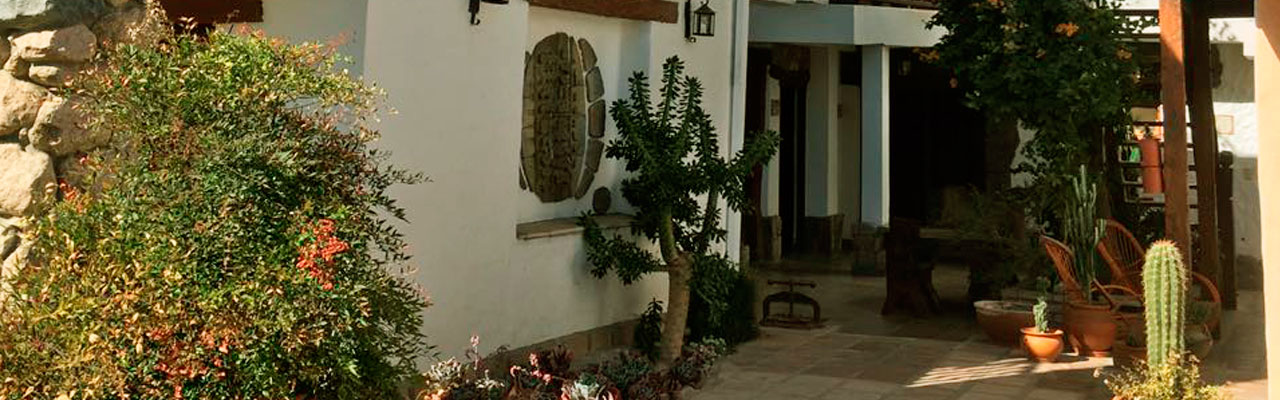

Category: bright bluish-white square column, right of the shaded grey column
[861, 45, 890, 227]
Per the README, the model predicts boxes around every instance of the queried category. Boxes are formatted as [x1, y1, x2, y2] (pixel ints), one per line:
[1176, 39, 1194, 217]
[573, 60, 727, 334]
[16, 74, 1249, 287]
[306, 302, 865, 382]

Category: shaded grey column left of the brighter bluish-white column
[804, 47, 840, 217]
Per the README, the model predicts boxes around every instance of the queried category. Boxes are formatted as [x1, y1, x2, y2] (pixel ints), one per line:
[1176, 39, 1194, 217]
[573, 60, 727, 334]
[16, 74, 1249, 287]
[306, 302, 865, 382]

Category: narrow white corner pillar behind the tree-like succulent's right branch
[721, 0, 751, 262]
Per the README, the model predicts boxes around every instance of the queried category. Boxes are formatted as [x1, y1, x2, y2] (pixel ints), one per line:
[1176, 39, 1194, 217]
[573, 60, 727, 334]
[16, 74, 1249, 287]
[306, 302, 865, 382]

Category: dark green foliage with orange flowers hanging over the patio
[922, 0, 1149, 230]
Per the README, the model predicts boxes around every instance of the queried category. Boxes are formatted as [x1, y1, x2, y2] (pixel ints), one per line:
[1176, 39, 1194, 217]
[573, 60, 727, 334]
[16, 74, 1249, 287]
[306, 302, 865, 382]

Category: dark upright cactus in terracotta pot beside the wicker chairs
[1062, 165, 1116, 356]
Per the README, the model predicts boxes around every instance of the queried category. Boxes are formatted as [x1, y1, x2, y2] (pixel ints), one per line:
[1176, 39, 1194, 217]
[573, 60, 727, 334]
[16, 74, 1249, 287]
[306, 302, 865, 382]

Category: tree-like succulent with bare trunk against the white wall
[581, 58, 778, 365]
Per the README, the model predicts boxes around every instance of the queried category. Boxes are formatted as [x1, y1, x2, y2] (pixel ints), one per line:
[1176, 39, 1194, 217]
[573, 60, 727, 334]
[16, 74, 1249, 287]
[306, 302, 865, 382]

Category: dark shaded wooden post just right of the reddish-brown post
[1187, 1, 1222, 287]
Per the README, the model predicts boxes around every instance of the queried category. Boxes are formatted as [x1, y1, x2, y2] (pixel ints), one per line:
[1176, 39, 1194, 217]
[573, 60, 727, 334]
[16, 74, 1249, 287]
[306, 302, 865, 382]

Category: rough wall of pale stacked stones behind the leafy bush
[0, 0, 146, 280]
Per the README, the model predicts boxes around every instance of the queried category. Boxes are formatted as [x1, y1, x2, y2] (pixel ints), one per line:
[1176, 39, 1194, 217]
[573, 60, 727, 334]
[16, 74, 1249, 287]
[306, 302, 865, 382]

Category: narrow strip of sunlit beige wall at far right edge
[1254, 0, 1280, 399]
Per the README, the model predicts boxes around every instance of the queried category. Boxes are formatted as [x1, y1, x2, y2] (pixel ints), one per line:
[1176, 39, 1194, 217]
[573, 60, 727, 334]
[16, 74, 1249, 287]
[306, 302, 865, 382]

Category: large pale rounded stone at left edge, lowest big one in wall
[0, 144, 54, 215]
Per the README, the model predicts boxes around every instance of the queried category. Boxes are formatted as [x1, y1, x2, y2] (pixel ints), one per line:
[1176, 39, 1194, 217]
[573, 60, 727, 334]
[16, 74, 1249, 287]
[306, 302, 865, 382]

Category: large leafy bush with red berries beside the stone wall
[0, 17, 429, 399]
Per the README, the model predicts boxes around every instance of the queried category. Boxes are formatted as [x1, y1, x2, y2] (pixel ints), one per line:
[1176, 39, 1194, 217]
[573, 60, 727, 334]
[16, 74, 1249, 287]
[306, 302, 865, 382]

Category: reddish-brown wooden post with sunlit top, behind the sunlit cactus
[1160, 0, 1192, 261]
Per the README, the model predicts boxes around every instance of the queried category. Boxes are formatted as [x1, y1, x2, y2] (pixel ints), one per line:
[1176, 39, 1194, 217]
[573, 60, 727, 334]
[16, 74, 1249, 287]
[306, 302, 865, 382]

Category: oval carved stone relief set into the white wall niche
[520, 33, 605, 203]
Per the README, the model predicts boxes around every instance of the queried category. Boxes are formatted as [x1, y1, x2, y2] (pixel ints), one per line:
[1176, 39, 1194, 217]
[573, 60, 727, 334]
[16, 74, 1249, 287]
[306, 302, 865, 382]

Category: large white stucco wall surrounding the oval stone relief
[345, 0, 733, 354]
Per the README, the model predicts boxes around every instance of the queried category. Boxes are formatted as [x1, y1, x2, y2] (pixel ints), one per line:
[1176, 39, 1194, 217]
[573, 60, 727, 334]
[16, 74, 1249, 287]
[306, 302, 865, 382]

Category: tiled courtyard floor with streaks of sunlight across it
[690, 262, 1266, 400]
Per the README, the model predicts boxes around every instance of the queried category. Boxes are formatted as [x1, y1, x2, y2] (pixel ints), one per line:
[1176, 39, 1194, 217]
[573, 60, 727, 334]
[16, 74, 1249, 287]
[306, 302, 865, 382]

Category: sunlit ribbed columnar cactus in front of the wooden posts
[1142, 241, 1188, 367]
